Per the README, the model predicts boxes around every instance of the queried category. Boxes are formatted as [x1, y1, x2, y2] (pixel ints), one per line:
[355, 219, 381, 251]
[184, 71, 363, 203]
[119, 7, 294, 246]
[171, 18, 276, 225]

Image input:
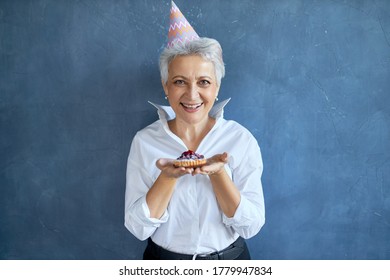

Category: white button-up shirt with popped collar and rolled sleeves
[125, 100, 265, 254]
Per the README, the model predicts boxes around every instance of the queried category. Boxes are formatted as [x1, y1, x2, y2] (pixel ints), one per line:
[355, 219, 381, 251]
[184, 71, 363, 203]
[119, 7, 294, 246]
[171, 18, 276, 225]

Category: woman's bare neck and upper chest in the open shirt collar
[168, 117, 215, 151]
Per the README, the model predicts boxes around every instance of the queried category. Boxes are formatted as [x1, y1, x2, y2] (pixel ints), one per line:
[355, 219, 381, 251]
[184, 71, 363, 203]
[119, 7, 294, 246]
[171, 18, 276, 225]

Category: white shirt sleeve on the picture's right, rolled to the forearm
[222, 137, 265, 238]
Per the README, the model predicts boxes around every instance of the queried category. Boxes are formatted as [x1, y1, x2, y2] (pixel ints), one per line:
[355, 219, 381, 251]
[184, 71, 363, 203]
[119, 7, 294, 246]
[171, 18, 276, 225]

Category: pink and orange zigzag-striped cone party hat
[168, 1, 199, 48]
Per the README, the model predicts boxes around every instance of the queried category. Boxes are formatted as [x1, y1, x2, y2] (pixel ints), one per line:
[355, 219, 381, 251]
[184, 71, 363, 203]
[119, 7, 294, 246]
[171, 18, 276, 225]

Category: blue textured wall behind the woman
[0, 0, 390, 259]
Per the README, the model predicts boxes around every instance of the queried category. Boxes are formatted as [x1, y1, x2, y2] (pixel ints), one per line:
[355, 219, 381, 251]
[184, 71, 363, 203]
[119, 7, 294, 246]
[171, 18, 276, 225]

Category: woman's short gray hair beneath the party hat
[160, 38, 225, 85]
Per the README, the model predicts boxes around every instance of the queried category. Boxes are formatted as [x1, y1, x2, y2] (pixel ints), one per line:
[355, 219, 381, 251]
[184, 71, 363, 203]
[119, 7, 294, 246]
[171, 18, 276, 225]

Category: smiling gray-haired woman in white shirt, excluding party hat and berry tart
[125, 38, 265, 259]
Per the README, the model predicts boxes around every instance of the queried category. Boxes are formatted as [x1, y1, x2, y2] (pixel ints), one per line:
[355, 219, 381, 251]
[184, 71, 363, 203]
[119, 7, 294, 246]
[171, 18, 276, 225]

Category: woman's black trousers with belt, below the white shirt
[143, 237, 251, 260]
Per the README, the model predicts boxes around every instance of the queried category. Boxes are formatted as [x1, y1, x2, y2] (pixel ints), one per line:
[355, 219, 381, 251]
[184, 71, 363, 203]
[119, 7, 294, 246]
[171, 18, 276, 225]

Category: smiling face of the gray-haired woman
[163, 55, 219, 124]
